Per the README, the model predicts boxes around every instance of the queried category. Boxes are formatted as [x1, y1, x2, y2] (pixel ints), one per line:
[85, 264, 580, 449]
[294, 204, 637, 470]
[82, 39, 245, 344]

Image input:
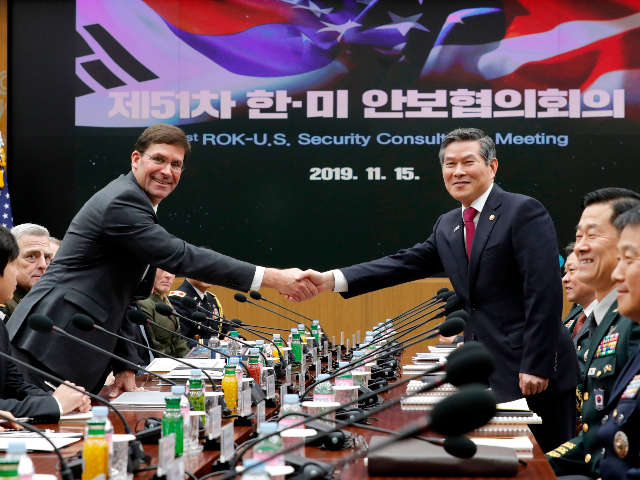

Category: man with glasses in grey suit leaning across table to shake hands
[7, 124, 317, 396]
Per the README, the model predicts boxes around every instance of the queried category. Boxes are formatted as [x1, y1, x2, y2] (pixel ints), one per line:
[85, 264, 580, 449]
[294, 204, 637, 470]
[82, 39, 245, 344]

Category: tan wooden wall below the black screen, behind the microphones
[173, 278, 570, 355]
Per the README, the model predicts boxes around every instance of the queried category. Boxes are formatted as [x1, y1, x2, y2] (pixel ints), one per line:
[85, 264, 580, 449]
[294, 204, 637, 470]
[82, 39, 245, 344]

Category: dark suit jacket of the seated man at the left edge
[0, 322, 60, 423]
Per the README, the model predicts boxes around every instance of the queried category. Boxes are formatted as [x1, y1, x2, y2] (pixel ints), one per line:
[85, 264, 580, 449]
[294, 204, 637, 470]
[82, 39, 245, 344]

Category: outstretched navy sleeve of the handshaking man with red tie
[340, 217, 444, 298]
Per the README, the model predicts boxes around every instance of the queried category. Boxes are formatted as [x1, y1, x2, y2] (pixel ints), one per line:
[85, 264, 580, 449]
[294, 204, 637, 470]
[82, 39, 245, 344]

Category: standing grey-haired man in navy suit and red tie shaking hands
[301, 128, 580, 448]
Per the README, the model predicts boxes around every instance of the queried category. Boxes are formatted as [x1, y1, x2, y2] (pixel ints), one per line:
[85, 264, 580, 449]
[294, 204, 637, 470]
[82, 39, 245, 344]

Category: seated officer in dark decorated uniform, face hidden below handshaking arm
[169, 278, 235, 347]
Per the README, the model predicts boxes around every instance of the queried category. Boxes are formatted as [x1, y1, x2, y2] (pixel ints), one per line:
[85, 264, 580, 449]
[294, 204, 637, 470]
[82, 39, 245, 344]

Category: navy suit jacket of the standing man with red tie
[341, 185, 580, 402]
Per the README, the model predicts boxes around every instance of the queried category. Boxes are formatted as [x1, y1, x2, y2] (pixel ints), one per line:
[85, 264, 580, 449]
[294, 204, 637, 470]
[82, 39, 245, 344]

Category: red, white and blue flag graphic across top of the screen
[76, 0, 640, 126]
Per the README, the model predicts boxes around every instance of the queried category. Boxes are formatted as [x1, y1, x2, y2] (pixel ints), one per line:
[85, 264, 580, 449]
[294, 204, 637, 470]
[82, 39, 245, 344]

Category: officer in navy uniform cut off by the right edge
[598, 203, 640, 480]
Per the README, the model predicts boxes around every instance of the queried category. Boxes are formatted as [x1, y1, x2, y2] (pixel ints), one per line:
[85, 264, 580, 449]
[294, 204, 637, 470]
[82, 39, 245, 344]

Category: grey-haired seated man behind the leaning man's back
[0, 223, 53, 323]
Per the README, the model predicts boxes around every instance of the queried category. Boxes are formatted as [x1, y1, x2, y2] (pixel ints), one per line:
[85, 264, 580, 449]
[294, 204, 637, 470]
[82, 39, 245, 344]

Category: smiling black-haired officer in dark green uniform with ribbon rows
[547, 188, 640, 478]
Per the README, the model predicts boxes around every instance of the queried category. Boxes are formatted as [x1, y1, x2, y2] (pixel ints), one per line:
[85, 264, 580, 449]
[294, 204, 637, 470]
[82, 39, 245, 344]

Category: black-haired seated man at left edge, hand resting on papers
[0, 226, 91, 423]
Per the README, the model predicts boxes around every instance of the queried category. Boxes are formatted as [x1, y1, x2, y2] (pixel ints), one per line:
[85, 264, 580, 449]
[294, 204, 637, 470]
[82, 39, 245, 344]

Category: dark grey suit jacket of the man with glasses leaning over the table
[7, 173, 256, 390]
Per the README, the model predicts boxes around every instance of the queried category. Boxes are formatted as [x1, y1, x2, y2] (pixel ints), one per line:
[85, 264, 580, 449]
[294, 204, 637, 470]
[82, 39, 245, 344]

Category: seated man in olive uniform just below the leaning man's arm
[138, 268, 189, 358]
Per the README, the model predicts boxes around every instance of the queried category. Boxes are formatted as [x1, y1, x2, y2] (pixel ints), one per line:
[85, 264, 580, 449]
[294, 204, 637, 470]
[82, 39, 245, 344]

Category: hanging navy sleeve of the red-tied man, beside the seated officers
[512, 198, 565, 378]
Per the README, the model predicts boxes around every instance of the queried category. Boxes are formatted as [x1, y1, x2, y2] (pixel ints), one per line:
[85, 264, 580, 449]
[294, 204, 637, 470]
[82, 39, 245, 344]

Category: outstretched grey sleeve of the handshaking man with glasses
[102, 190, 256, 292]
